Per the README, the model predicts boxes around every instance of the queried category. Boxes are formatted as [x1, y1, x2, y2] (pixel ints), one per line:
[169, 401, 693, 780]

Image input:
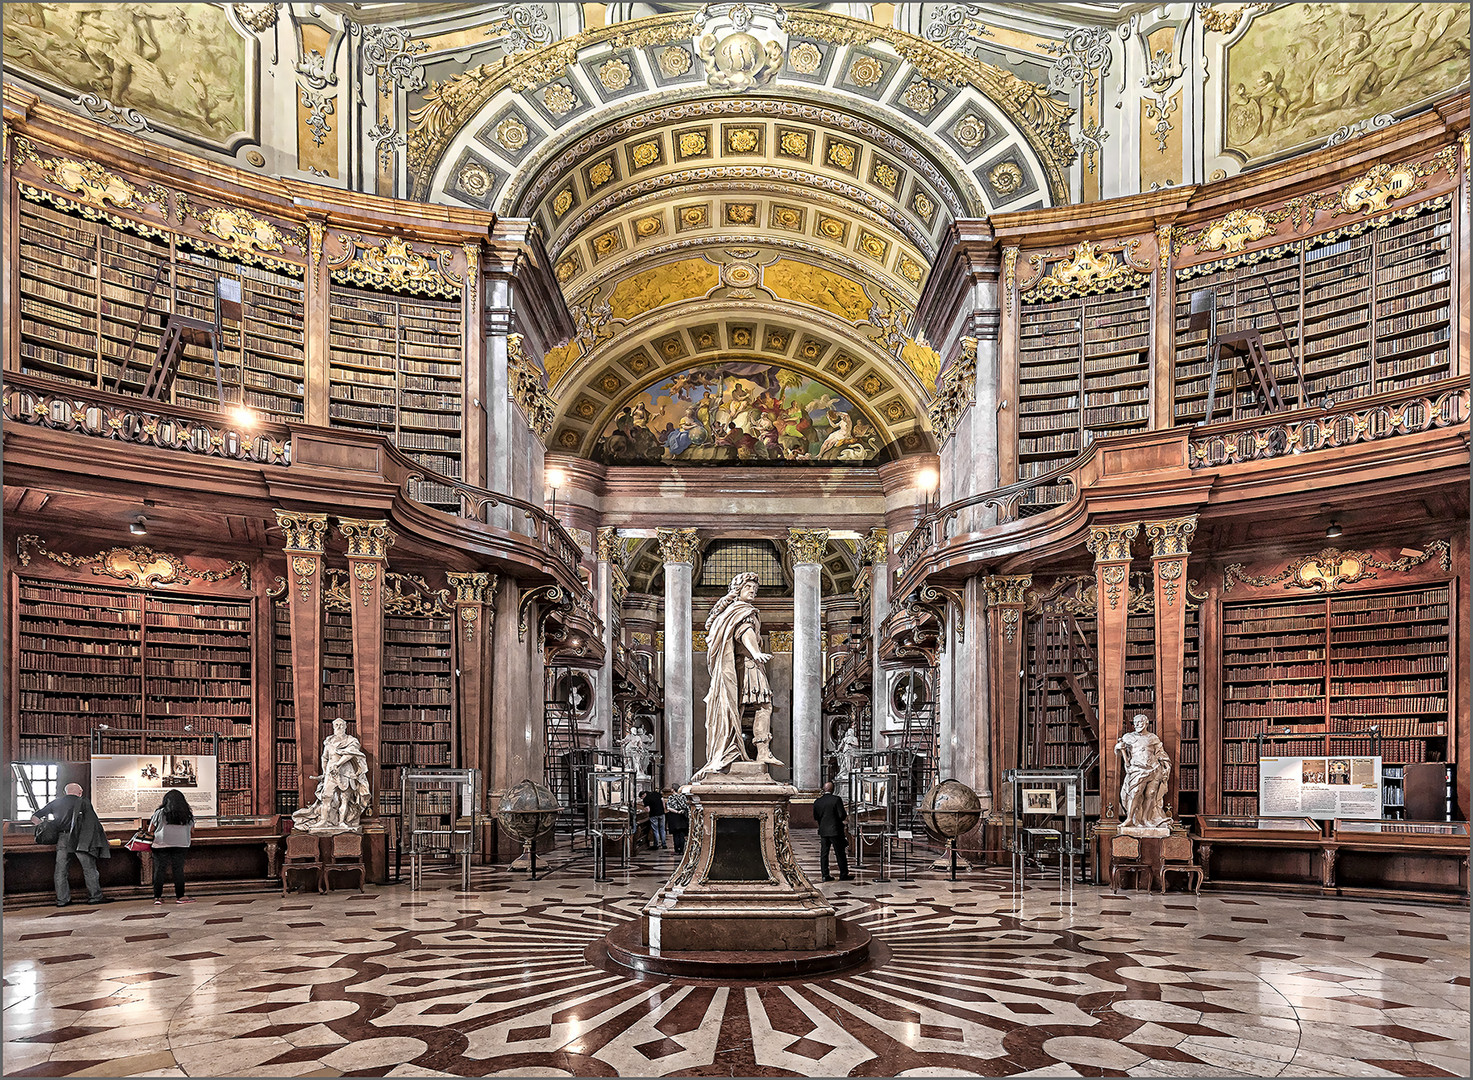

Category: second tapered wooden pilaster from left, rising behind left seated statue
[337, 517, 393, 815]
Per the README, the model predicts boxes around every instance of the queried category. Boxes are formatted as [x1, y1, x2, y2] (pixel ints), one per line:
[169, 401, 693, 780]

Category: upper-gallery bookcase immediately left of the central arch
[327, 284, 464, 511]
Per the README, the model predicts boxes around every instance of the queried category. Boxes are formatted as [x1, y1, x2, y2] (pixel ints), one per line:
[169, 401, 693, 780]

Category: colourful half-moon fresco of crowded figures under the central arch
[595, 361, 884, 464]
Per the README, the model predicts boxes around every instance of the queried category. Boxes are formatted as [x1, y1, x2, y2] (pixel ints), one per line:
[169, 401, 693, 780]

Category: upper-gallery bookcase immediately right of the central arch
[1018, 289, 1150, 508]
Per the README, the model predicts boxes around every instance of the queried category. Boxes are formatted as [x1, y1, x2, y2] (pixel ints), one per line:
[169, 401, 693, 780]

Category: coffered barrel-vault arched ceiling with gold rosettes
[408, 10, 1072, 461]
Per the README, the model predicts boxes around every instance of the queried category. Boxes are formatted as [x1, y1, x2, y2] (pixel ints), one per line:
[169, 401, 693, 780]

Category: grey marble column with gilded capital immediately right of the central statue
[788, 529, 828, 793]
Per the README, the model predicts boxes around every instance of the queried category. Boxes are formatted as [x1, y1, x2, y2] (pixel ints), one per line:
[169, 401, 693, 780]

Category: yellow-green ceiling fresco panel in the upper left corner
[4, 3, 253, 141]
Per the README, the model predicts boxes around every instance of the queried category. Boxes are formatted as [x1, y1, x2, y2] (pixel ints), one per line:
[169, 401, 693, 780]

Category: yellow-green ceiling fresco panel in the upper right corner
[1224, 3, 1469, 161]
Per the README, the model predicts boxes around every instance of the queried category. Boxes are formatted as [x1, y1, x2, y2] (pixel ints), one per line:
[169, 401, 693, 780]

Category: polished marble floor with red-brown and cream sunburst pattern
[3, 834, 1469, 1077]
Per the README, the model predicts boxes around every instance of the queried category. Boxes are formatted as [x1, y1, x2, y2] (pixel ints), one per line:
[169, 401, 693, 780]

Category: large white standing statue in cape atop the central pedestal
[691, 573, 782, 781]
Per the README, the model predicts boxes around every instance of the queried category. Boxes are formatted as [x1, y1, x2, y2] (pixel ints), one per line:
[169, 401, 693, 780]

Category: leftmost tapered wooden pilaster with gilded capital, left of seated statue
[275, 510, 327, 806]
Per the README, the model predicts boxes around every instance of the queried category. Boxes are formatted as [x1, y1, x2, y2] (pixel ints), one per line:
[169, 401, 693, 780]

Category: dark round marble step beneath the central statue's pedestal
[589, 919, 876, 981]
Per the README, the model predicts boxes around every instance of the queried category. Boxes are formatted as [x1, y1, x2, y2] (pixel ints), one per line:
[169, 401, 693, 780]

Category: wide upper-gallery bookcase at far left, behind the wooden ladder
[18, 200, 306, 420]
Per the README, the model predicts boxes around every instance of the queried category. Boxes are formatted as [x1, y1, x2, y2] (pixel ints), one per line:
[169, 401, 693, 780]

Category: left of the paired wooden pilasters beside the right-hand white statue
[1087, 522, 1140, 824]
